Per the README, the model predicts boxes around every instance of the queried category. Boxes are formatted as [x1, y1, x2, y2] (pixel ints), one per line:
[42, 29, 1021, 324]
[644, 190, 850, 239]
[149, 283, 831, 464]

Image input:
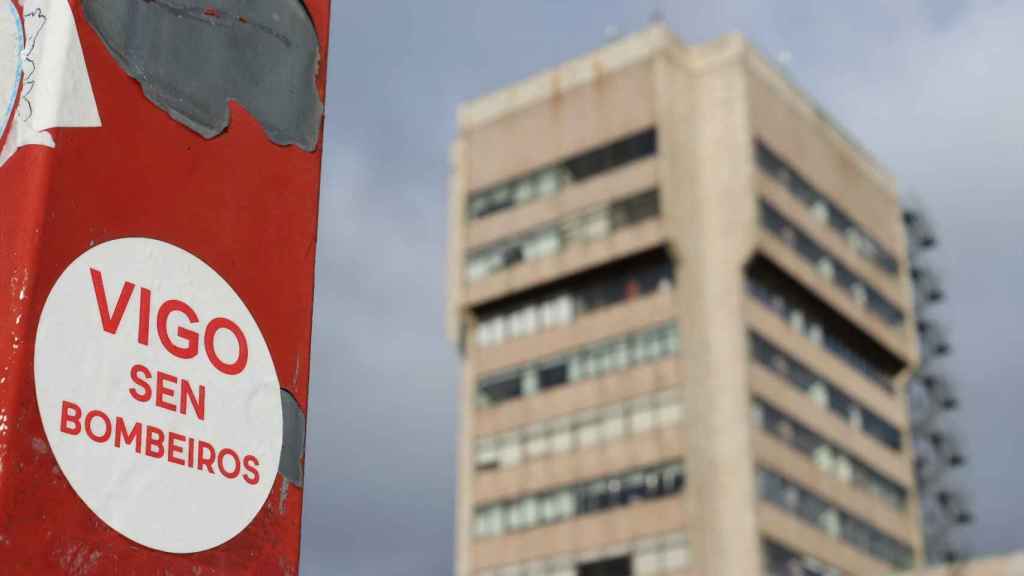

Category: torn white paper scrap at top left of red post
[0, 0, 100, 166]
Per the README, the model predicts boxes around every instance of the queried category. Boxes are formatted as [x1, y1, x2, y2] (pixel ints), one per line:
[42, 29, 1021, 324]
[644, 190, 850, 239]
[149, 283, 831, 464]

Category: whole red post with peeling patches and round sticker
[0, 0, 330, 574]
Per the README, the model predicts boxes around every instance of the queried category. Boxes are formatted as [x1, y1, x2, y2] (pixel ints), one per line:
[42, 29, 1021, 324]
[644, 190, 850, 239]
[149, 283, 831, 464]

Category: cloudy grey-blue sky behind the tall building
[302, 0, 1024, 576]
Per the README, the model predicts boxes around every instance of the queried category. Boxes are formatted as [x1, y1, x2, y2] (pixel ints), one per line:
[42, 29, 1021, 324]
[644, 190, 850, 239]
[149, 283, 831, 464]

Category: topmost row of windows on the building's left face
[468, 130, 656, 220]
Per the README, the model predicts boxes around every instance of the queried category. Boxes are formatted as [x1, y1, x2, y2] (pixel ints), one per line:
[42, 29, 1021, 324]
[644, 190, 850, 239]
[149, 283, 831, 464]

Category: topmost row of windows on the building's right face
[757, 141, 899, 275]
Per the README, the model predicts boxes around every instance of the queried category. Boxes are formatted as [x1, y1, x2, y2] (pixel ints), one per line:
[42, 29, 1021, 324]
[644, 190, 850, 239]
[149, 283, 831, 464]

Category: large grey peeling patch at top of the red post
[85, 0, 324, 151]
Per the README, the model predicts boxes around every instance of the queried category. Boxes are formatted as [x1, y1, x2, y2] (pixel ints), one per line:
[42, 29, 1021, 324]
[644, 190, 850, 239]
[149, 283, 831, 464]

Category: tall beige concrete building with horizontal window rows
[449, 26, 922, 576]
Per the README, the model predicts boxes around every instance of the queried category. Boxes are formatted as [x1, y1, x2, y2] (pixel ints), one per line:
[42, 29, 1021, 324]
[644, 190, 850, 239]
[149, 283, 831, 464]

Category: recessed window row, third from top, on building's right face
[746, 260, 895, 394]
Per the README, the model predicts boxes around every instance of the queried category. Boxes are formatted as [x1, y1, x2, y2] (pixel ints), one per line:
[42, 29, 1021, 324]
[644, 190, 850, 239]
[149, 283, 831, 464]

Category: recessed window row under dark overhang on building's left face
[475, 250, 673, 347]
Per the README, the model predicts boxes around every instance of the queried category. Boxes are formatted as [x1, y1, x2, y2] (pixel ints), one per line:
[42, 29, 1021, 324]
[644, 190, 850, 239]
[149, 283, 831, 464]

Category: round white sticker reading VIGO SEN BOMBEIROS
[35, 238, 282, 553]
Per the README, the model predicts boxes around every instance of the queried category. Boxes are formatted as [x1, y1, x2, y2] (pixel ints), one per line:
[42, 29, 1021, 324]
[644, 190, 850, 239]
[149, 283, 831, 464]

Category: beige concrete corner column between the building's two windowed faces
[655, 38, 761, 575]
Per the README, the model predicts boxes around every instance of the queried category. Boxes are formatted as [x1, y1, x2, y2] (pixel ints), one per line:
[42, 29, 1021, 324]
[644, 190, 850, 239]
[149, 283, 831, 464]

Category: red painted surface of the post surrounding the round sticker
[0, 0, 330, 575]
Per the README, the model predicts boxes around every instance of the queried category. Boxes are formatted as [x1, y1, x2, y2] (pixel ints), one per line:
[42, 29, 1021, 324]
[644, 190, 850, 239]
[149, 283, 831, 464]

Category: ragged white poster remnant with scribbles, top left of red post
[0, 0, 100, 166]
